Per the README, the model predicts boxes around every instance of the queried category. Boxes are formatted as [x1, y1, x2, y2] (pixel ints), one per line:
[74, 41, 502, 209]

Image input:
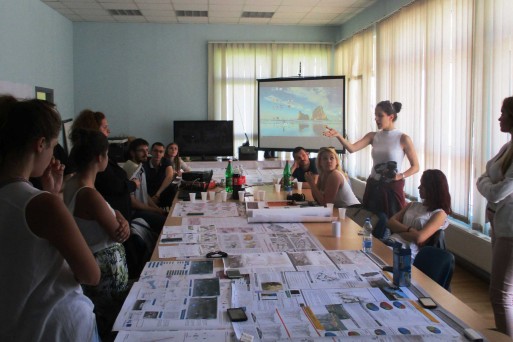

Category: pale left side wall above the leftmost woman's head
[0, 0, 74, 118]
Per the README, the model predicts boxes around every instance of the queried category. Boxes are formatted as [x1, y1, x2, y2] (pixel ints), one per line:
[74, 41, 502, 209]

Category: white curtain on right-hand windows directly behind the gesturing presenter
[376, 0, 473, 218]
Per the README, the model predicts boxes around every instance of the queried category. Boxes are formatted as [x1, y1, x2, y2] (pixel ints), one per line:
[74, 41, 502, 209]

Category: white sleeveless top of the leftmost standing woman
[0, 182, 96, 341]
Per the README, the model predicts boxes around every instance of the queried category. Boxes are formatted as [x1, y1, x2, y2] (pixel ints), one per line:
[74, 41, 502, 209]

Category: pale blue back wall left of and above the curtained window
[74, 23, 338, 144]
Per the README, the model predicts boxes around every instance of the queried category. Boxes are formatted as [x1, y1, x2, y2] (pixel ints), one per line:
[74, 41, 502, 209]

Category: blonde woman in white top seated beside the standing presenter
[305, 147, 360, 208]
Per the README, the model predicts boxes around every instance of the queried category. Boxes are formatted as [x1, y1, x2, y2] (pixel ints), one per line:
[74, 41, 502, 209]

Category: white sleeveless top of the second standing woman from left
[67, 186, 116, 253]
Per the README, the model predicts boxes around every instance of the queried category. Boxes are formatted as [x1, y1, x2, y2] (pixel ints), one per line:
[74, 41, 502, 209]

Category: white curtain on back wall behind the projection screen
[208, 42, 332, 158]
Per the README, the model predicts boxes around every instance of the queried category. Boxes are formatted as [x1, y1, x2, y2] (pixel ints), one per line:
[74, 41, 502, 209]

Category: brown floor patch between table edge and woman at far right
[451, 264, 495, 328]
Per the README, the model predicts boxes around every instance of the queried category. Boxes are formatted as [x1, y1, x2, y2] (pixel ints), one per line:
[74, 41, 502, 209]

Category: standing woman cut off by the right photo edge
[477, 97, 513, 336]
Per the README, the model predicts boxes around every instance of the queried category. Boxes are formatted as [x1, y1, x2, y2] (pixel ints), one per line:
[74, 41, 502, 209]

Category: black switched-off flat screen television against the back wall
[173, 120, 233, 160]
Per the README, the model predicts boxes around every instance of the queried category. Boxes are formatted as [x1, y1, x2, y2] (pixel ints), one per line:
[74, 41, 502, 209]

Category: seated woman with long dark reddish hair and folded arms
[382, 170, 452, 260]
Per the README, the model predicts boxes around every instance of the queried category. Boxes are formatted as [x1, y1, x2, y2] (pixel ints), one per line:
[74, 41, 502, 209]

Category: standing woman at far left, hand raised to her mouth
[0, 96, 100, 341]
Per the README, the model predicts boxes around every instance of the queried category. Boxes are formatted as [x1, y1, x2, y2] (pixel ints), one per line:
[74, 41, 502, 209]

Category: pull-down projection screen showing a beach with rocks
[258, 76, 345, 153]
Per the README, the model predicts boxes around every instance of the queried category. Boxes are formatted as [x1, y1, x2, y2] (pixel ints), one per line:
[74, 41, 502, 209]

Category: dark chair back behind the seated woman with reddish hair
[413, 246, 454, 291]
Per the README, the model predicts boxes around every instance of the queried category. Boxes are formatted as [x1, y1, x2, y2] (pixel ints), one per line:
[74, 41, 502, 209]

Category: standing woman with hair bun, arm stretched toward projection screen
[323, 101, 419, 217]
